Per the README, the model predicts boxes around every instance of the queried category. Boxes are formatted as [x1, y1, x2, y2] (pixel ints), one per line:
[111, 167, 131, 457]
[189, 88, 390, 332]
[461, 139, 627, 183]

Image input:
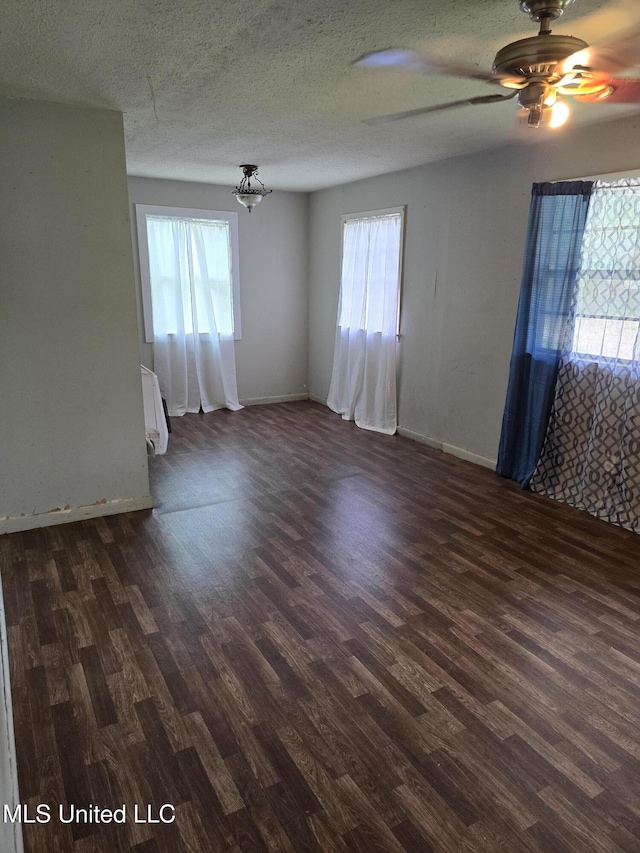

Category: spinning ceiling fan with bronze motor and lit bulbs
[354, 0, 640, 127]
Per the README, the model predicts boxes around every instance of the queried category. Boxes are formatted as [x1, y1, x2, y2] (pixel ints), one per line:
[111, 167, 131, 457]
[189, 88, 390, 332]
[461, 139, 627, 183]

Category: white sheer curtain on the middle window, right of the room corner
[327, 213, 402, 435]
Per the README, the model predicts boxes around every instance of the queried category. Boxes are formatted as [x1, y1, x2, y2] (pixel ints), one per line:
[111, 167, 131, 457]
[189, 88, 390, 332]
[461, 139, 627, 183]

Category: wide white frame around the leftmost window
[135, 204, 242, 344]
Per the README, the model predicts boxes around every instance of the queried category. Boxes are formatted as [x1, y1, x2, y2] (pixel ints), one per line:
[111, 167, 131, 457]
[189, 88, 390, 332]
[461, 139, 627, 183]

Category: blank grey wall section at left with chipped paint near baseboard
[0, 100, 151, 532]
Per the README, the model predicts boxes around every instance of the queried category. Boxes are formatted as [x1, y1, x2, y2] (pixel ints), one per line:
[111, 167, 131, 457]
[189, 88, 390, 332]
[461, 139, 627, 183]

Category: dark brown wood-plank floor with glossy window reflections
[0, 403, 640, 853]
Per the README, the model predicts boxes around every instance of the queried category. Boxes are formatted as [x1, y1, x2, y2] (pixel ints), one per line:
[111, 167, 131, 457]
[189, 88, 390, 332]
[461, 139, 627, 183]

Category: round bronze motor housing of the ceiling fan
[493, 35, 588, 84]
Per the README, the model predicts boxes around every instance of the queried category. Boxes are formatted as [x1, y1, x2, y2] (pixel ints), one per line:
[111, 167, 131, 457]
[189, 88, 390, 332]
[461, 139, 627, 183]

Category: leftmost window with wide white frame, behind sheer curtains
[136, 204, 241, 343]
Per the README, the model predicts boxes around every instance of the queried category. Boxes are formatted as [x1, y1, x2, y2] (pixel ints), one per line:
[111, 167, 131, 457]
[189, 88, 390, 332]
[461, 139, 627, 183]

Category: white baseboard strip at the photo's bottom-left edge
[0, 568, 24, 853]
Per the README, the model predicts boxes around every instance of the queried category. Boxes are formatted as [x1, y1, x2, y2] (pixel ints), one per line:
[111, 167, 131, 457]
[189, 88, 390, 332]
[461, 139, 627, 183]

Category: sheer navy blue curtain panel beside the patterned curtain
[496, 181, 593, 489]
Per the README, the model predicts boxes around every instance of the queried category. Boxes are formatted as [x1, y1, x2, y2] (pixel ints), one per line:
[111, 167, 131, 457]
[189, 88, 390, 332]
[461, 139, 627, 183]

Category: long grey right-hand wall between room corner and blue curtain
[309, 117, 640, 460]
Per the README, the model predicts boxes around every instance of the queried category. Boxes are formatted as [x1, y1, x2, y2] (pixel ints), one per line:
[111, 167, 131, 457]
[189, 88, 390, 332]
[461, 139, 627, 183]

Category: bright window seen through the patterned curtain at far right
[572, 185, 640, 361]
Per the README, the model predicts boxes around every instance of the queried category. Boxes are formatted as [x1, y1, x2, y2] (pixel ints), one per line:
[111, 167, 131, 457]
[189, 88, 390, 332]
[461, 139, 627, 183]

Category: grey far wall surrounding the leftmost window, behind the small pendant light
[129, 172, 308, 403]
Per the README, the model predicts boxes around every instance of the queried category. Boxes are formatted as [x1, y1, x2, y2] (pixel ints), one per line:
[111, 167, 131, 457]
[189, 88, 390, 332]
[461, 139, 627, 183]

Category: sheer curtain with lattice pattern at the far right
[530, 179, 640, 531]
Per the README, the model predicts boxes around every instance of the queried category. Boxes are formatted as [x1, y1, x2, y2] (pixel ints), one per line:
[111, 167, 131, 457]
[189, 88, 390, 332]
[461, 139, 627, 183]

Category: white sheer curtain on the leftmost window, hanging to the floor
[147, 216, 242, 415]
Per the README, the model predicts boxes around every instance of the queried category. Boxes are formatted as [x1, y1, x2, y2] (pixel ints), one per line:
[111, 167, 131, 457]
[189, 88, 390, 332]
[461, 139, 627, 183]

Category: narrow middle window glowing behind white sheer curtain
[338, 208, 404, 335]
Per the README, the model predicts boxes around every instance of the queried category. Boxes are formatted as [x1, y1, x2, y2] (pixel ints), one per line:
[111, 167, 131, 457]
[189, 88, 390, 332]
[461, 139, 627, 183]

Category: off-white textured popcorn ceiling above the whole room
[0, 0, 637, 190]
